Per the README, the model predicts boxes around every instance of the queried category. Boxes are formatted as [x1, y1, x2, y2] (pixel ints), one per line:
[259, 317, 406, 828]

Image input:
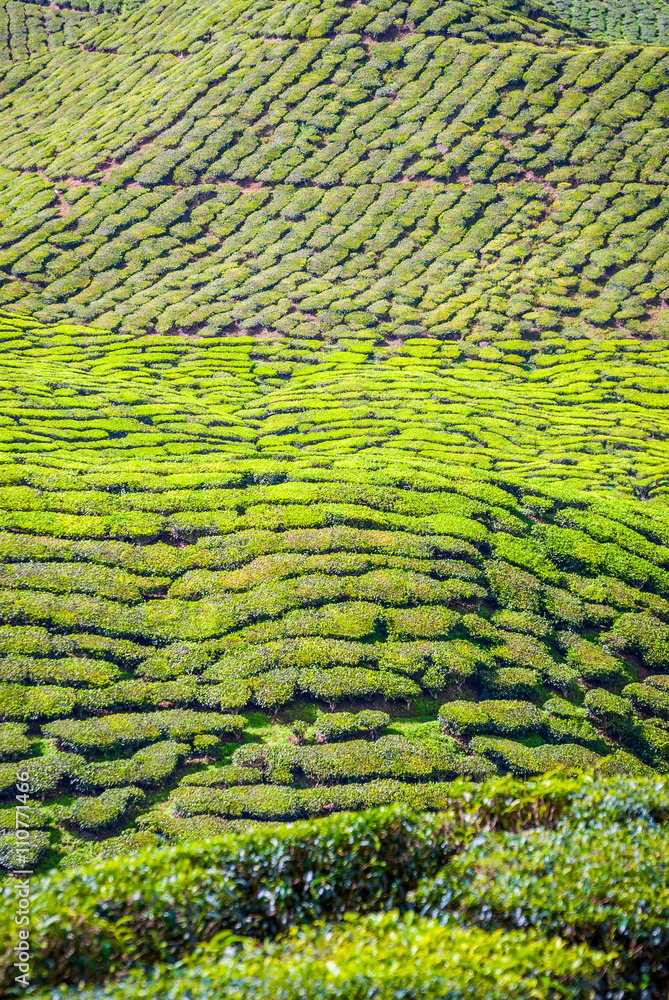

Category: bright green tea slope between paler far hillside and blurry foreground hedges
[0, 304, 669, 865]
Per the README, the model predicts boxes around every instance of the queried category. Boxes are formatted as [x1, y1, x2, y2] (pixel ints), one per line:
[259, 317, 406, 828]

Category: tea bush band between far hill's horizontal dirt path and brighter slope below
[0, 173, 668, 344]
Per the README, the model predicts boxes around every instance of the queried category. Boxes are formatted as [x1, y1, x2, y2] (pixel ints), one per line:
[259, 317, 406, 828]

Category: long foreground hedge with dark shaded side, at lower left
[0, 808, 449, 988]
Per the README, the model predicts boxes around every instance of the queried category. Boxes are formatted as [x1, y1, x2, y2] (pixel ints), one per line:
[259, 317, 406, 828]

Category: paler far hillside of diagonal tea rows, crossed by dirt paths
[0, 2, 669, 340]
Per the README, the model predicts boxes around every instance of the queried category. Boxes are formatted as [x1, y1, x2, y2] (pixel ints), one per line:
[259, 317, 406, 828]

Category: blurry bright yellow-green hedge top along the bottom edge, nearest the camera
[41, 913, 608, 1000]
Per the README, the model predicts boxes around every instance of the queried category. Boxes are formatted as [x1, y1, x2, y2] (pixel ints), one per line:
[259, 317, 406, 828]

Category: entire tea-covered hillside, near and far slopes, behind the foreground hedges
[0, 0, 669, 868]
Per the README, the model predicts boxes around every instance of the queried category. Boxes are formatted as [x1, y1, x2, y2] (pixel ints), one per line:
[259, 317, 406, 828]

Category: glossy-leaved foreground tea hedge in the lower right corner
[416, 796, 669, 997]
